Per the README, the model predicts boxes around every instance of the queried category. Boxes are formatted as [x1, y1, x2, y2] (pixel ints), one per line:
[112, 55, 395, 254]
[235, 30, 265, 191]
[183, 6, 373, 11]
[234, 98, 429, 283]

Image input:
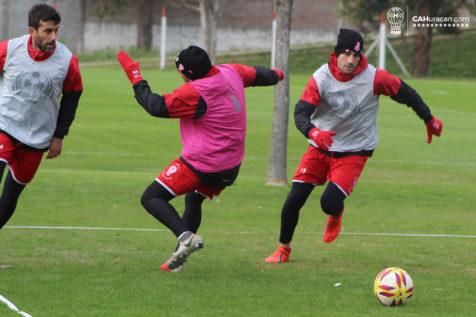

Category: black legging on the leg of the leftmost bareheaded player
[0, 161, 25, 229]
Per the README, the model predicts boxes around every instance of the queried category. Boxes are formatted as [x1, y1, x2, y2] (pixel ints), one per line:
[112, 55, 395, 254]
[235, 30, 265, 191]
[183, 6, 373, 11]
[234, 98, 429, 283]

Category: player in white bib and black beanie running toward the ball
[265, 29, 443, 263]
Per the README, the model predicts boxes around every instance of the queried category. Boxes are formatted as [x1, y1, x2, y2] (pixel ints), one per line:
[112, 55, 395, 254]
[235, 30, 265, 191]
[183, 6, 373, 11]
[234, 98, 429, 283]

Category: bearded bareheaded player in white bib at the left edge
[0, 4, 83, 228]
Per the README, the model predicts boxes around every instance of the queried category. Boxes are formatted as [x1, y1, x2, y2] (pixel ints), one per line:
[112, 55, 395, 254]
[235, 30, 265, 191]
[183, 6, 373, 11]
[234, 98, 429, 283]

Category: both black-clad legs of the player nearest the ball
[279, 182, 346, 243]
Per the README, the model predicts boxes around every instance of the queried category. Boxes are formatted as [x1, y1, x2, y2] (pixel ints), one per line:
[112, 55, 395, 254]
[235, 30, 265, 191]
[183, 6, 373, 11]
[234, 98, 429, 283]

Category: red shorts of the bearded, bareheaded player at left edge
[0, 132, 43, 185]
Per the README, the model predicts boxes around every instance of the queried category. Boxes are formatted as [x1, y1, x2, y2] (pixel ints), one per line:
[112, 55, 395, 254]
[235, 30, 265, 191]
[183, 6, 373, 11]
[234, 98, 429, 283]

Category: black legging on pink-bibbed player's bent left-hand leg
[141, 182, 190, 237]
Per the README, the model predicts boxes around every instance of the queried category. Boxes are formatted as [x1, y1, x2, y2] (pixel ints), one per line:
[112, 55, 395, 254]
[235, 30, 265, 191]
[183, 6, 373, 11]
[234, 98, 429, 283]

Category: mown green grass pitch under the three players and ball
[0, 67, 476, 317]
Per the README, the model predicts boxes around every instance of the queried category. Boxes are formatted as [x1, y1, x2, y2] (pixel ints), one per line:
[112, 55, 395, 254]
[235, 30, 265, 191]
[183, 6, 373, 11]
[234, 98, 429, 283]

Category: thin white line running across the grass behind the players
[5, 226, 476, 239]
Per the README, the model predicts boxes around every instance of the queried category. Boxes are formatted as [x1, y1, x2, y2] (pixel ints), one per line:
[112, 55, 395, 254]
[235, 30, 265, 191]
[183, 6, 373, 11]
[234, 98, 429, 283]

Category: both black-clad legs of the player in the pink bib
[141, 181, 205, 237]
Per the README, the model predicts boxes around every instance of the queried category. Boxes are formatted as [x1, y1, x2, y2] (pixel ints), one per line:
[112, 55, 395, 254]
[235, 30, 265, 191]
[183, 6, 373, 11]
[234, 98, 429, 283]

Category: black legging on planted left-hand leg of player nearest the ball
[279, 182, 314, 243]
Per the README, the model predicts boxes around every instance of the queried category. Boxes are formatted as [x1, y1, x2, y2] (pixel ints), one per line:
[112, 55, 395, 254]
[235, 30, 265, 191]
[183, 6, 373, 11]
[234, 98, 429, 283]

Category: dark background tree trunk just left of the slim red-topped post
[137, 0, 155, 50]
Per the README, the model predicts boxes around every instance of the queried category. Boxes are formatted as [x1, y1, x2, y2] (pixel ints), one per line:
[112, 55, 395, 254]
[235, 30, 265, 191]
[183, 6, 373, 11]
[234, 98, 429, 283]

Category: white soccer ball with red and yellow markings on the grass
[374, 267, 413, 306]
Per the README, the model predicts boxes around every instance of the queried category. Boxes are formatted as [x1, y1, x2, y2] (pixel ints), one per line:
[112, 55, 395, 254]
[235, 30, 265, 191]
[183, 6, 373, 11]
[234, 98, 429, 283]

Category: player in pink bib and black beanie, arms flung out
[117, 46, 283, 272]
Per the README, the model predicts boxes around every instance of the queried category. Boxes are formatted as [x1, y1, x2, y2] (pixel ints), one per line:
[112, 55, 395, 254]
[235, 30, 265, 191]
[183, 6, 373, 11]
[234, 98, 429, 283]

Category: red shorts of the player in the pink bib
[155, 158, 225, 199]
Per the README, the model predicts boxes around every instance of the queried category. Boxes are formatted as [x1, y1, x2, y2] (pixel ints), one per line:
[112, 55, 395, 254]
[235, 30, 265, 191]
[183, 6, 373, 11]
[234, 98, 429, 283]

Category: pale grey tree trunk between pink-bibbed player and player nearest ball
[267, 0, 293, 186]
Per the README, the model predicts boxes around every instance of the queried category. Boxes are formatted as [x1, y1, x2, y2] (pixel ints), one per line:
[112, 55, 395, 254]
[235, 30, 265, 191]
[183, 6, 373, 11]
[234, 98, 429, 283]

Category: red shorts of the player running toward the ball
[293, 146, 369, 196]
